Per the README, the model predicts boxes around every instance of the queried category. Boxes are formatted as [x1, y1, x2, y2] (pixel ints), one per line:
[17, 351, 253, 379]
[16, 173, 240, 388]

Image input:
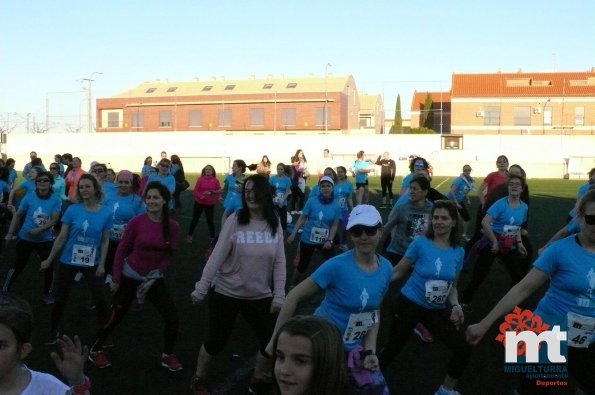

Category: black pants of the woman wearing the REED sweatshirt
[204, 289, 276, 355]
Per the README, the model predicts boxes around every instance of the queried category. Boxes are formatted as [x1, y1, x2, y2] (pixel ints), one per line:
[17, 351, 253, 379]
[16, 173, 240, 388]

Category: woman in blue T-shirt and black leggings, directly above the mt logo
[461, 174, 529, 310]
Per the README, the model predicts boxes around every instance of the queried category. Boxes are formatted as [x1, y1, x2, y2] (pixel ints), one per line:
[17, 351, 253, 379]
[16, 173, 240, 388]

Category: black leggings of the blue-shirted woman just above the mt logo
[461, 248, 529, 303]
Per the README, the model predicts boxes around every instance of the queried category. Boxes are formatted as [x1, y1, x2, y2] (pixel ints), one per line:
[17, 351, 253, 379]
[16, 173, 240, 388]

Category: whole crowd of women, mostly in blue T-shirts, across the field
[0, 150, 595, 395]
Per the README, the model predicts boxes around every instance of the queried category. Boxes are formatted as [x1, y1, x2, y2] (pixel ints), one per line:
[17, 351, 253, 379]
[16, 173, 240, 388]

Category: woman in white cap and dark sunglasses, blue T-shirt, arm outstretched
[267, 206, 392, 394]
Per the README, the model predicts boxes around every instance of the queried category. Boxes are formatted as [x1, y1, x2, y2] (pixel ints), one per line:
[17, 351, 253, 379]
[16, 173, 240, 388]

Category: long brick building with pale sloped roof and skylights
[96, 75, 372, 133]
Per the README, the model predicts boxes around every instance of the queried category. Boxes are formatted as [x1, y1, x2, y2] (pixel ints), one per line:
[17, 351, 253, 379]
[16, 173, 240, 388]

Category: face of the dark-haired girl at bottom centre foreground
[275, 332, 314, 395]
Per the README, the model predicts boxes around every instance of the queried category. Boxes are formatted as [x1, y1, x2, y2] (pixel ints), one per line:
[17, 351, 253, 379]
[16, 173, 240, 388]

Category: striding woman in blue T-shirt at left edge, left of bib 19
[2, 169, 62, 304]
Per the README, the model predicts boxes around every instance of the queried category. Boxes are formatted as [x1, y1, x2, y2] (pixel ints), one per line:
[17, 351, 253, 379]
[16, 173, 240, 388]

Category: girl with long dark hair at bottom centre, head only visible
[273, 316, 354, 395]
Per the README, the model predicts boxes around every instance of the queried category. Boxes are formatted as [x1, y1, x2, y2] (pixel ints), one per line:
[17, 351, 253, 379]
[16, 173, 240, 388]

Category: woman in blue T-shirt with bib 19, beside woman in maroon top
[41, 174, 112, 344]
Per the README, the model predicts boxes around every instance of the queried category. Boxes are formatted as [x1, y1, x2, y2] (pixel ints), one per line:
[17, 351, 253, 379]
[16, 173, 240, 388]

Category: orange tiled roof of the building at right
[451, 71, 595, 98]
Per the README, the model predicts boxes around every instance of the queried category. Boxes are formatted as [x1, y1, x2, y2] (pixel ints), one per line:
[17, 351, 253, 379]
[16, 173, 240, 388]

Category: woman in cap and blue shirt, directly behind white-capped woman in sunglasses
[287, 176, 341, 285]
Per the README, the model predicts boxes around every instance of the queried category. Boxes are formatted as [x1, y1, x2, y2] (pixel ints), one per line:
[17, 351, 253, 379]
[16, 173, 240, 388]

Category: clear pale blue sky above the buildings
[0, 0, 595, 132]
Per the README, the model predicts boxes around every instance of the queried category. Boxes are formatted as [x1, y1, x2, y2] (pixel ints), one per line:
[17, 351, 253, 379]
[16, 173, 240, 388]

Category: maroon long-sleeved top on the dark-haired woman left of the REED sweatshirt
[112, 214, 180, 283]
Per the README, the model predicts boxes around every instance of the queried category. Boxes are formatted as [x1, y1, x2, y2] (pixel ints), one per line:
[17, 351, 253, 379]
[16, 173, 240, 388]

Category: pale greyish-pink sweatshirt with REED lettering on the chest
[193, 213, 286, 305]
